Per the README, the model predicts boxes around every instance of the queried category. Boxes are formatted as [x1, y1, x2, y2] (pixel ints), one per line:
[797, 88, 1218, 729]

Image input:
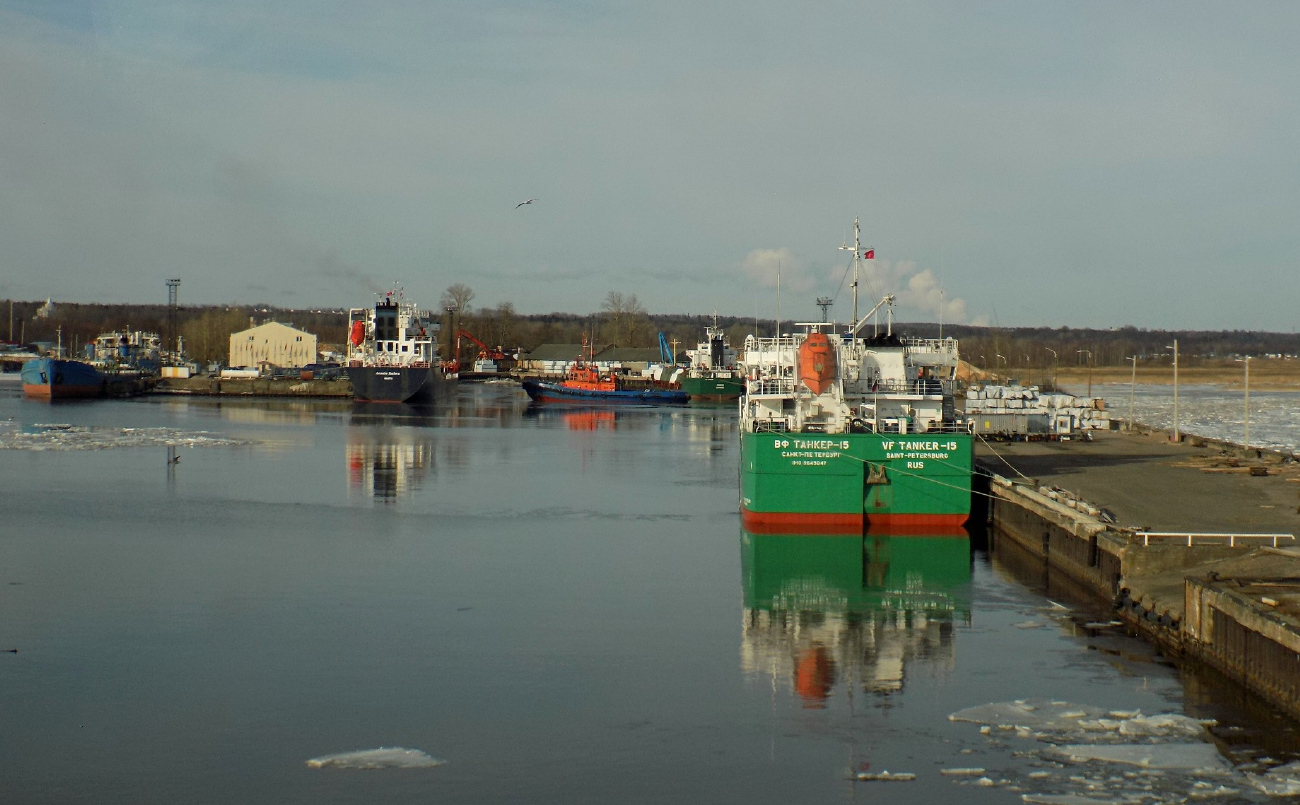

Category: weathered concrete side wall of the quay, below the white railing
[976, 467, 1300, 718]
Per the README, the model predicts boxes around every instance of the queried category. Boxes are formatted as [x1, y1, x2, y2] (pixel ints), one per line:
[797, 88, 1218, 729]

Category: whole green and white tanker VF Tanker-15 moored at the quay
[740, 222, 972, 533]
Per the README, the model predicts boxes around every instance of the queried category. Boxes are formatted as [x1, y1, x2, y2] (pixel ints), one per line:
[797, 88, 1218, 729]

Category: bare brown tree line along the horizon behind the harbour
[10, 293, 1300, 371]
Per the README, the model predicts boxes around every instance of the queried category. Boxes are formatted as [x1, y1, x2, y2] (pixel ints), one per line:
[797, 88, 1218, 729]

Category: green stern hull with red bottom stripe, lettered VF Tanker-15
[741, 432, 971, 533]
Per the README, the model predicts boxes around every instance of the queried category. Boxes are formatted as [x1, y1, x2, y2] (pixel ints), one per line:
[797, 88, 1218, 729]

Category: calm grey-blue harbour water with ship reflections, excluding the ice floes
[0, 382, 1294, 802]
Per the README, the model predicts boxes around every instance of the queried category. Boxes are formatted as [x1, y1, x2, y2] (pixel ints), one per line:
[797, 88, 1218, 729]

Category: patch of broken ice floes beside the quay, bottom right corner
[941, 700, 1300, 805]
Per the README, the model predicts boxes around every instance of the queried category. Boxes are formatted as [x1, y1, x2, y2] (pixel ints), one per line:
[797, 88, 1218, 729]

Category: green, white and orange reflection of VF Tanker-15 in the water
[741, 532, 971, 707]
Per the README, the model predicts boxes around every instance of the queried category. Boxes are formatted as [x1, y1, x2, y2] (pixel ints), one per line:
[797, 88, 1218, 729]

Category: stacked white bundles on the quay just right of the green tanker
[966, 385, 1112, 436]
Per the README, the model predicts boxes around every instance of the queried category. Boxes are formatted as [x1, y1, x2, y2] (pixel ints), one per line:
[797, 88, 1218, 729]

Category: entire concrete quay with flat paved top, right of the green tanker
[972, 429, 1300, 718]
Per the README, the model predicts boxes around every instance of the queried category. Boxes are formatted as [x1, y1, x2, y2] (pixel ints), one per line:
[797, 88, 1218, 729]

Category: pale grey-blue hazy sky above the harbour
[0, 0, 1300, 332]
